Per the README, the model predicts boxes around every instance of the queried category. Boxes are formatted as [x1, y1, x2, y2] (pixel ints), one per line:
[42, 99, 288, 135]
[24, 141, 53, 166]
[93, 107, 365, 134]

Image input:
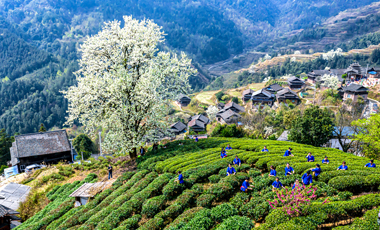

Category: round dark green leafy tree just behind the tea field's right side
[289, 106, 334, 147]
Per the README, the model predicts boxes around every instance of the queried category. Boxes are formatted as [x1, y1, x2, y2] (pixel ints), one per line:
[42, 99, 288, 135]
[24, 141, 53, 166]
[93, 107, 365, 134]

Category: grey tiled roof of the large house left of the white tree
[15, 130, 71, 158]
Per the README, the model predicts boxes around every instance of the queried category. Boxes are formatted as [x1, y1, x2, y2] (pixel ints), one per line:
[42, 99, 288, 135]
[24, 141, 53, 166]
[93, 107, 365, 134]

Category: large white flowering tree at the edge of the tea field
[63, 16, 195, 158]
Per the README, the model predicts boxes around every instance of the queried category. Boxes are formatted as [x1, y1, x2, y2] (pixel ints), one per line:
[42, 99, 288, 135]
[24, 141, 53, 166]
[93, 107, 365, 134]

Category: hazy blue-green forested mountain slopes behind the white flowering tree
[0, 0, 378, 135]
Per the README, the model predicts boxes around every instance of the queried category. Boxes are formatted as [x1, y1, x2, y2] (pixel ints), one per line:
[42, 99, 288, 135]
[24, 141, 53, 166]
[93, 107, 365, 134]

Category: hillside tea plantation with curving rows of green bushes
[16, 138, 380, 230]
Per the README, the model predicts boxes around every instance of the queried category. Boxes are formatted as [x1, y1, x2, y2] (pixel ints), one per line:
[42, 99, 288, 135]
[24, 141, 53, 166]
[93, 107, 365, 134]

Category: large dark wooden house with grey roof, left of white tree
[10, 130, 72, 172]
